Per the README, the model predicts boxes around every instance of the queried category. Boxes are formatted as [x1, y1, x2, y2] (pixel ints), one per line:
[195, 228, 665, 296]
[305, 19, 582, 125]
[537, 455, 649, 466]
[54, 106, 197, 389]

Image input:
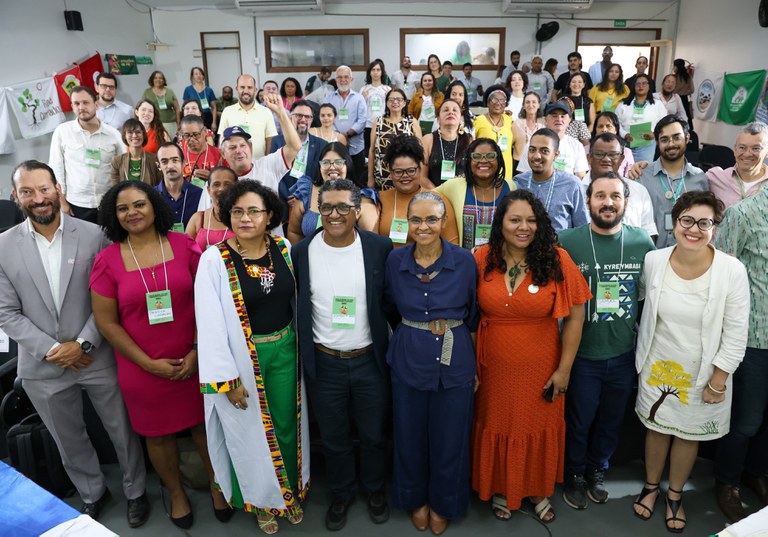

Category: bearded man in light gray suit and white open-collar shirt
[0, 160, 149, 527]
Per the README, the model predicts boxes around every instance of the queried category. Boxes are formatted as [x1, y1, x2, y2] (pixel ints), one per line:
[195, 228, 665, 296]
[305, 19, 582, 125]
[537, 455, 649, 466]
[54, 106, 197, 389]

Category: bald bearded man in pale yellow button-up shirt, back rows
[218, 75, 277, 158]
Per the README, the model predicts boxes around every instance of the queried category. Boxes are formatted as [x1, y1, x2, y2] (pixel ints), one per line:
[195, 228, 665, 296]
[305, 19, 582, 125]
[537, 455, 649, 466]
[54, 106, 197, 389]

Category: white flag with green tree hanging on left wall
[5, 78, 65, 138]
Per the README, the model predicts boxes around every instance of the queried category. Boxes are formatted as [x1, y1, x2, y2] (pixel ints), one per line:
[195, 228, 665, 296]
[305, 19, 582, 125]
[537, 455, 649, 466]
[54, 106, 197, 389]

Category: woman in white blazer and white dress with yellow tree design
[634, 192, 749, 533]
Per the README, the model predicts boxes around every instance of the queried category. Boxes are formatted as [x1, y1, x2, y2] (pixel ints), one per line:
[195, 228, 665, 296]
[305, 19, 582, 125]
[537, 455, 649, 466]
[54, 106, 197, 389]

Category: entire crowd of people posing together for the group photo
[0, 47, 768, 535]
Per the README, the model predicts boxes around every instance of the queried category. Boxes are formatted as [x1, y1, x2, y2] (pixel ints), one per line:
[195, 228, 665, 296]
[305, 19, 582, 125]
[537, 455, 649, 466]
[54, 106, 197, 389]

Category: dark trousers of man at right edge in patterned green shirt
[715, 347, 768, 485]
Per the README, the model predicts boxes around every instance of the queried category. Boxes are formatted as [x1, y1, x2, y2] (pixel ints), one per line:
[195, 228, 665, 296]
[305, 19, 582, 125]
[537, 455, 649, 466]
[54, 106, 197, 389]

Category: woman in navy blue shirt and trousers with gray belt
[385, 192, 479, 535]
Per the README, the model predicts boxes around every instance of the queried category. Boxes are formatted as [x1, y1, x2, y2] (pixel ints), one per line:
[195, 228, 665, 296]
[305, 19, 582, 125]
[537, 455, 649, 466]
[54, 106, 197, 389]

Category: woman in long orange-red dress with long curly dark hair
[472, 190, 591, 522]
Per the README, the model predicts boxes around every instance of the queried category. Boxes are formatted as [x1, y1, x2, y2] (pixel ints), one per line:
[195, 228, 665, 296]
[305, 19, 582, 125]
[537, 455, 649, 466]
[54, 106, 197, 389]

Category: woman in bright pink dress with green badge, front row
[90, 181, 232, 529]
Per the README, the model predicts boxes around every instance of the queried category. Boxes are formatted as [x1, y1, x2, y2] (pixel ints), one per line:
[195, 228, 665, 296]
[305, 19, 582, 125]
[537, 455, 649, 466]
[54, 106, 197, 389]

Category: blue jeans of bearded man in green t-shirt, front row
[565, 352, 637, 475]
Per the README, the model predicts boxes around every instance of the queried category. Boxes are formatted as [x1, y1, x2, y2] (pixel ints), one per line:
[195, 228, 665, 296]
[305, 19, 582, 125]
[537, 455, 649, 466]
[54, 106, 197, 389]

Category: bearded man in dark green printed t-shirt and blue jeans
[560, 172, 655, 509]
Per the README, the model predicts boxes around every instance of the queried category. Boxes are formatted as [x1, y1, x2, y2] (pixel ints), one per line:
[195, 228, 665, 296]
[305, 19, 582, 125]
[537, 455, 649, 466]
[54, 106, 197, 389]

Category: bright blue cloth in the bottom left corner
[0, 462, 80, 537]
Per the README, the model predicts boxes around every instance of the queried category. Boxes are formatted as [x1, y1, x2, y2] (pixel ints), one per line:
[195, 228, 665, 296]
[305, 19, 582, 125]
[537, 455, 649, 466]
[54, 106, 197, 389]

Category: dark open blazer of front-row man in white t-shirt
[291, 228, 392, 380]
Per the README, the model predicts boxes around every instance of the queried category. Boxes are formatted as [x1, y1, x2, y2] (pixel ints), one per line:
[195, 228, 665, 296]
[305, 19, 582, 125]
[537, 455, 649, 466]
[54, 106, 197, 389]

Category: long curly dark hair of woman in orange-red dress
[483, 189, 563, 287]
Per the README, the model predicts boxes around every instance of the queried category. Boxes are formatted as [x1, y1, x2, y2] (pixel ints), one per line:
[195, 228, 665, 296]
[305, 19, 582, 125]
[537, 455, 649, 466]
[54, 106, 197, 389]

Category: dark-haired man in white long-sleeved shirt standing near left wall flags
[48, 86, 125, 224]
